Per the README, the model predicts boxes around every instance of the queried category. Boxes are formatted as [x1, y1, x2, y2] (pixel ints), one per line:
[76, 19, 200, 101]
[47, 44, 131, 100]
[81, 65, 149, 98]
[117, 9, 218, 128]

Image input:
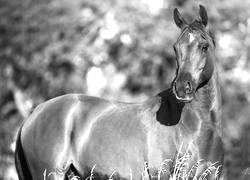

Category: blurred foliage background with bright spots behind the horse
[0, 0, 250, 180]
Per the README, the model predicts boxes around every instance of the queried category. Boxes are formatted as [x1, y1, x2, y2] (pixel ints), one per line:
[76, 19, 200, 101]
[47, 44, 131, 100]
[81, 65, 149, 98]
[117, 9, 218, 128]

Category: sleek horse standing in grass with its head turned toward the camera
[15, 6, 223, 180]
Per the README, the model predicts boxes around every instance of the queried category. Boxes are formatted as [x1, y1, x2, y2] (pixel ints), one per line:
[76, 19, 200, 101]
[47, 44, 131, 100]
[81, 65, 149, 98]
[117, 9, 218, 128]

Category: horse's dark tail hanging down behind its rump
[15, 126, 32, 180]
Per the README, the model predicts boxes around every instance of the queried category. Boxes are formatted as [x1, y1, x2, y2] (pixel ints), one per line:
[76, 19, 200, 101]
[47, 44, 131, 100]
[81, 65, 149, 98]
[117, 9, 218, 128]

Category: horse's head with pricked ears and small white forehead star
[172, 5, 215, 102]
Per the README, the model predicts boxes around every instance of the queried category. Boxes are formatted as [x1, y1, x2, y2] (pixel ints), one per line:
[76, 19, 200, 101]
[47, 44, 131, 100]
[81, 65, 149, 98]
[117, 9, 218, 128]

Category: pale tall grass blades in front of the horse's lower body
[43, 145, 223, 180]
